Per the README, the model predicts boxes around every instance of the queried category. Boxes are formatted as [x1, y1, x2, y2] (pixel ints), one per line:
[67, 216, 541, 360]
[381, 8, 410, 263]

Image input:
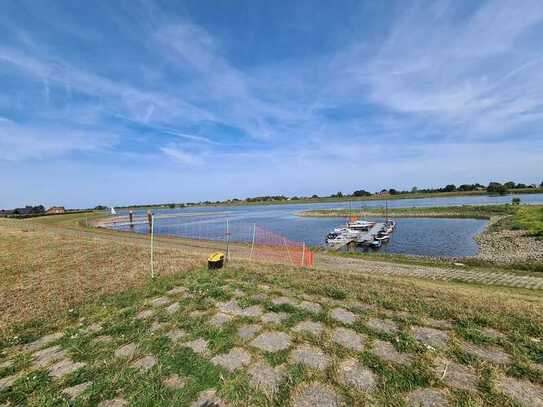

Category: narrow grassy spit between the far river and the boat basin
[298, 204, 528, 219]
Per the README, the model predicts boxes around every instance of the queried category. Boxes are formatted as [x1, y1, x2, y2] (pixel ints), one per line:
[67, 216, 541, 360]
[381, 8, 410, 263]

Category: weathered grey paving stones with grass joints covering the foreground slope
[0, 282, 543, 406]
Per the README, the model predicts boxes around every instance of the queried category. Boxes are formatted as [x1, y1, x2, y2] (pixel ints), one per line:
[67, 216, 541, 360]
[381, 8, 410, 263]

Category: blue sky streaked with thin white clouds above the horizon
[0, 0, 543, 207]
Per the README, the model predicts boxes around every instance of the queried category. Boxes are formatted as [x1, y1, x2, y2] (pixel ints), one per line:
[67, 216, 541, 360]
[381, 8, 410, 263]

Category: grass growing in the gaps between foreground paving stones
[0, 266, 543, 406]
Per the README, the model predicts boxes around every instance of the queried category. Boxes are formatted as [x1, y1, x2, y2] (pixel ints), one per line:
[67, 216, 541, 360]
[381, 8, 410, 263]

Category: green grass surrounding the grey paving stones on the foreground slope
[0, 266, 543, 406]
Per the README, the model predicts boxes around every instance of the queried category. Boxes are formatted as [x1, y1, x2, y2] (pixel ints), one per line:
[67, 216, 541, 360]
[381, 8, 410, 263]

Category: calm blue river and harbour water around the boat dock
[115, 194, 543, 256]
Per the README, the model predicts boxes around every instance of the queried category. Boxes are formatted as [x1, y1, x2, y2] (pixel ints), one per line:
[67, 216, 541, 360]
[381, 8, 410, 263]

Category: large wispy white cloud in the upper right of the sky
[340, 1, 543, 139]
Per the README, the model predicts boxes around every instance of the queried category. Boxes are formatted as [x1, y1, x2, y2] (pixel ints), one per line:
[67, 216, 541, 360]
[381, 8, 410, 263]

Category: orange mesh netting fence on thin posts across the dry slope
[0, 216, 313, 331]
